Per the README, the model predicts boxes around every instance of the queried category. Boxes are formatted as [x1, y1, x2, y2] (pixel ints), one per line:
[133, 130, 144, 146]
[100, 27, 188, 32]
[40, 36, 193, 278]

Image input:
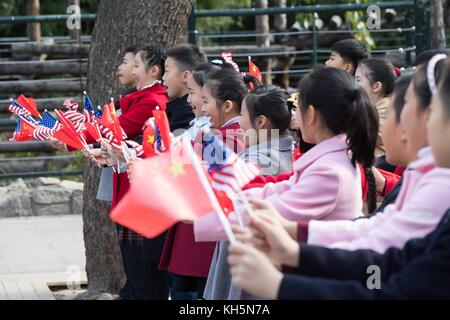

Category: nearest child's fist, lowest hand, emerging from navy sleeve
[228, 242, 283, 299]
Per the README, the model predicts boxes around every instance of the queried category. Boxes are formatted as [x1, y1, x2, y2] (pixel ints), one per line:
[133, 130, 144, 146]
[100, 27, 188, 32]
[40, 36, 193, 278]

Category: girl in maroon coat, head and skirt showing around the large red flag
[160, 64, 247, 299]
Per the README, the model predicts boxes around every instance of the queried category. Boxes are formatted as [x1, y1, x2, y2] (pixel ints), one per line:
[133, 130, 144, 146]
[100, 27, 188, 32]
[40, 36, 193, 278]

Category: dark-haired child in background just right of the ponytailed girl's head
[355, 58, 397, 158]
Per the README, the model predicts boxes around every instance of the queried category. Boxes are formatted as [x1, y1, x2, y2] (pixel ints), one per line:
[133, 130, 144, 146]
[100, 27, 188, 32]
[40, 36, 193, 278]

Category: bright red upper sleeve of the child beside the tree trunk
[118, 98, 161, 140]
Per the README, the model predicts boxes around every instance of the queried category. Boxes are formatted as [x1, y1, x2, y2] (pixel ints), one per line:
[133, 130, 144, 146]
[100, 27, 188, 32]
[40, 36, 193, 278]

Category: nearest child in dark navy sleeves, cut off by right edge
[228, 59, 450, 300]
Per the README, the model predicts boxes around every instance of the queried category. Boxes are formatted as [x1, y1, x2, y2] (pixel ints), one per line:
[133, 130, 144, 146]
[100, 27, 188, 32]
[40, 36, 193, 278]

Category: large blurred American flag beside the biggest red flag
[203, 130, 259, 198]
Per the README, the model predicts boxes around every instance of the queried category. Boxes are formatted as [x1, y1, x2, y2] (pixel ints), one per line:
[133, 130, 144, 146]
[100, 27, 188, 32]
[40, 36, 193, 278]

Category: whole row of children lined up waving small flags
[52, 39, 450, 300]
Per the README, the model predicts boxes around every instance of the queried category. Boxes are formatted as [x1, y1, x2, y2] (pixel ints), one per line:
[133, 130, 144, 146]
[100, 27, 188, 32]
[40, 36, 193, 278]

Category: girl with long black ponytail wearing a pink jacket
[194, 68, 378, 241]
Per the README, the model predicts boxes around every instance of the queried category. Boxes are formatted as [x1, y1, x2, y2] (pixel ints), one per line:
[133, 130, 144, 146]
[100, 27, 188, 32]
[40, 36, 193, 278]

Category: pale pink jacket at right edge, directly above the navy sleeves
[307, 147, 450, 253]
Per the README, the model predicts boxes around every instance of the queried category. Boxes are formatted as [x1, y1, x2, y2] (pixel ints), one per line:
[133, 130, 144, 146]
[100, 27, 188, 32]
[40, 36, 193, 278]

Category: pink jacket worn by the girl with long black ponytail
[194, 134, 362, 241]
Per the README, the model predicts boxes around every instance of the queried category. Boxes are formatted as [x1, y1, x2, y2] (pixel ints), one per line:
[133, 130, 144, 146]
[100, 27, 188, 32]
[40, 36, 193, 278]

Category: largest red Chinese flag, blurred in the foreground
[111, 143, 214, 238]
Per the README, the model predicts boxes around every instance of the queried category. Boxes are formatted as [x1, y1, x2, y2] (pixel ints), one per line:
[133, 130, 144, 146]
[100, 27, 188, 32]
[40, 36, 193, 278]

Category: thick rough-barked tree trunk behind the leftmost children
[83, 0, 192, 298]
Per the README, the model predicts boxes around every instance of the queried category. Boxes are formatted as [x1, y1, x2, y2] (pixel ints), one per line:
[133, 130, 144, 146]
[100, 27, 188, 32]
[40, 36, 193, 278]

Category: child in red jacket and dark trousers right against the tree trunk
[112, 45, 168, 300]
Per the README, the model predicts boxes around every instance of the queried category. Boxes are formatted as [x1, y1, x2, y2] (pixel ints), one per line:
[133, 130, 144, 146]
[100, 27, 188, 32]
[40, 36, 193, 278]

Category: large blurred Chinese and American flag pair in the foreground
[107, 127, 259, 238]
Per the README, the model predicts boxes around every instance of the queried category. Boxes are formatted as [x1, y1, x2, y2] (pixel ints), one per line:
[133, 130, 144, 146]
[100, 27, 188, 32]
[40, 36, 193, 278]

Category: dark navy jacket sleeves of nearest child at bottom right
[278, 210, 450, 300]
